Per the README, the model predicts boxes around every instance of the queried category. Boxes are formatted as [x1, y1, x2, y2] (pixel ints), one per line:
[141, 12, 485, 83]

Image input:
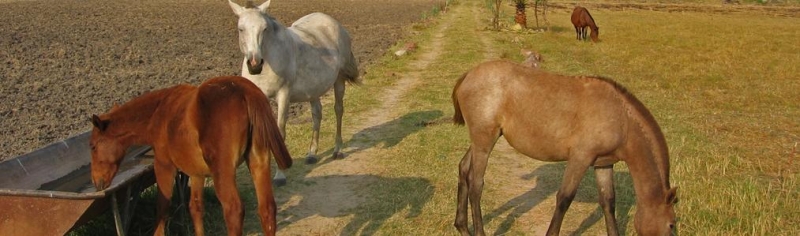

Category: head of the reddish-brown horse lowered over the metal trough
[89, 115, 125, 191]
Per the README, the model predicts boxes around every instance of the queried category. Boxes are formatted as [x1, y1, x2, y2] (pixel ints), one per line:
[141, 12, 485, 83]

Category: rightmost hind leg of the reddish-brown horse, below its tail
[247, 147, 277, 235]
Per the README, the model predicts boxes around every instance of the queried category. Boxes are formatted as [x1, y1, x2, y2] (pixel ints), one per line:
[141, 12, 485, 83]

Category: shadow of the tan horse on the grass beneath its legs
[484, 163, 633, 235]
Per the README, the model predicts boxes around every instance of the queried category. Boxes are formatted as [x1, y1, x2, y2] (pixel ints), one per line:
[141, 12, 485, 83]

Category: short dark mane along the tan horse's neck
[590, 76, 670, 189]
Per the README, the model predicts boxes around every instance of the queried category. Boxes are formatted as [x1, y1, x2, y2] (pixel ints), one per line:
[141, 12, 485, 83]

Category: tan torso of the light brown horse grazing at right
[456, 61, 625, 161]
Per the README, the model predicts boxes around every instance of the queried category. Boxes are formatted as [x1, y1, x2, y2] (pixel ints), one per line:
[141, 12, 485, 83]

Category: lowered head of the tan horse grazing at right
[633, 188, 678, 236]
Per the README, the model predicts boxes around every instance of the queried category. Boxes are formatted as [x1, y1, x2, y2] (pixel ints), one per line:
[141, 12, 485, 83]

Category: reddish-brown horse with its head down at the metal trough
[90, 76, 292, 235]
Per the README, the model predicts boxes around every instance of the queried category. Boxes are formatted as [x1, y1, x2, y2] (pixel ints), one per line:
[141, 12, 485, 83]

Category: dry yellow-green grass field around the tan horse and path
[72, 0, 800, 235]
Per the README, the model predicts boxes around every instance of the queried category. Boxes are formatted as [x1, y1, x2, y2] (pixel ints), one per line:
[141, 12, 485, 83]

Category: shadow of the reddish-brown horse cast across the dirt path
[250, 175, 434, 235]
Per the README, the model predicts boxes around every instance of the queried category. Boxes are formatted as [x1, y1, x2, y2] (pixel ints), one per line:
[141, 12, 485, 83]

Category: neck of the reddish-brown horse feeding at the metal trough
[109, 87, 175, 145]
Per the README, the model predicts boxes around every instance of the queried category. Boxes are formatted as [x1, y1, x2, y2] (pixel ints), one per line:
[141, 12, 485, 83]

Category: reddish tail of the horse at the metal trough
[243, 81, 292, 170]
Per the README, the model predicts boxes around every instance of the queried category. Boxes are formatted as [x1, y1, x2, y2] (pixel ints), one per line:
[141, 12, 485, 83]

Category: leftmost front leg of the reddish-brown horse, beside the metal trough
[153, 158, 177, 236]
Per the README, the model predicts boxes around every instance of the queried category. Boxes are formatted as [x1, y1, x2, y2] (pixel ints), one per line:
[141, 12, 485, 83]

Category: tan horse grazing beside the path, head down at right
[453, 61, 676, 235]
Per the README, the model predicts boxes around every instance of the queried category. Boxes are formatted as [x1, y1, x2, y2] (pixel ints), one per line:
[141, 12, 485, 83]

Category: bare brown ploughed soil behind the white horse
[0, 0, 441, 160]
